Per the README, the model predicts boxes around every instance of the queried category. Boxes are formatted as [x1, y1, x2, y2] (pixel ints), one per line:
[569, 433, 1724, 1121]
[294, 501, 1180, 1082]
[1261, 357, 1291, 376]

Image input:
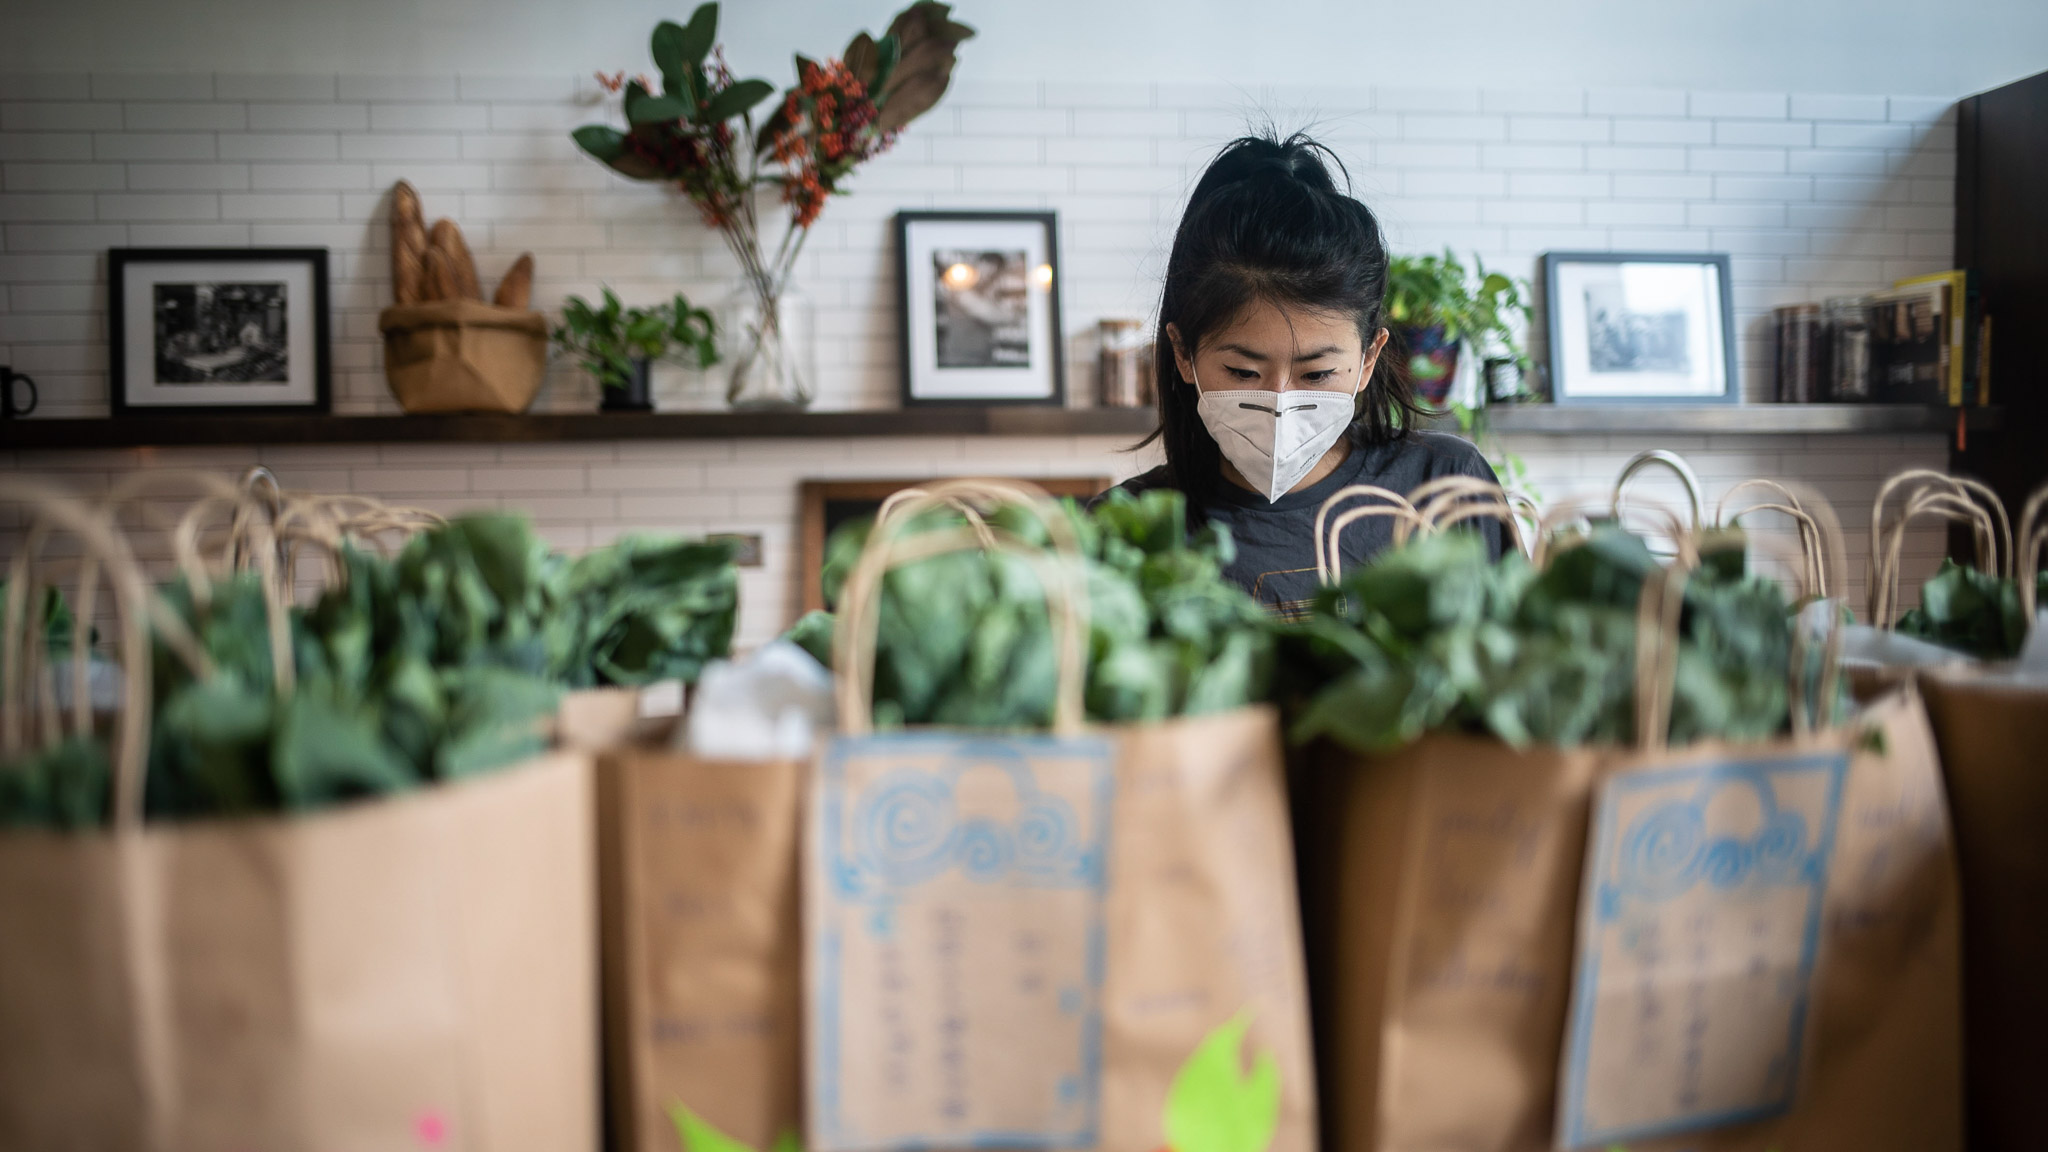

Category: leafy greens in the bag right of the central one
[1282, 525, 1818, 750]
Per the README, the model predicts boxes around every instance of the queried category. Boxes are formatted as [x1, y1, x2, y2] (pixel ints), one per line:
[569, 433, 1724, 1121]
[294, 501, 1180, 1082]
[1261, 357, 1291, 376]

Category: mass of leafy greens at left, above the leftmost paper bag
[0, 515, 737, 828]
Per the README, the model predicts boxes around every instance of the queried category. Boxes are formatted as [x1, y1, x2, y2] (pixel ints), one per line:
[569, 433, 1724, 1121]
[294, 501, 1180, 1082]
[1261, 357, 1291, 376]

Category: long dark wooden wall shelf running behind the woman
[0, 404, 1999, 451]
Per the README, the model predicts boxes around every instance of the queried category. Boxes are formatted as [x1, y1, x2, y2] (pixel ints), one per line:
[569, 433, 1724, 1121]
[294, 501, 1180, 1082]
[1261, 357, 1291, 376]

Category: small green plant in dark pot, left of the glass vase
[555, 289, 719, 412]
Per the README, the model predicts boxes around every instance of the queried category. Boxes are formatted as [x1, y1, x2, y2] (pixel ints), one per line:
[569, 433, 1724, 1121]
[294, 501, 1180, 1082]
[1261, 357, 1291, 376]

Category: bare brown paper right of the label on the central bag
[1096, 707, 1317, 1152]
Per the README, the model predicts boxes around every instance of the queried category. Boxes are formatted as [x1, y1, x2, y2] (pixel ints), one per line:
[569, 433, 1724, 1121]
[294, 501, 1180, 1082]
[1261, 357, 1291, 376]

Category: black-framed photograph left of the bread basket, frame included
[106, 248, 330, 416]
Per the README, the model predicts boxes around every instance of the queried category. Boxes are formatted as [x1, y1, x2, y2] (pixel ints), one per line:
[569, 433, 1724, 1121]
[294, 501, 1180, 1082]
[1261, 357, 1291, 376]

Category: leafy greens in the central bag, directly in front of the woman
[788, 490, 1272, 728]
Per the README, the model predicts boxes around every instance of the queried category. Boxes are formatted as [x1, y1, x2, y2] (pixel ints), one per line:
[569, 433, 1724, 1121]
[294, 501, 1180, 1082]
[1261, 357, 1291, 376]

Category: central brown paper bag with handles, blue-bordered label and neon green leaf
[805, 486, 1317, 1152]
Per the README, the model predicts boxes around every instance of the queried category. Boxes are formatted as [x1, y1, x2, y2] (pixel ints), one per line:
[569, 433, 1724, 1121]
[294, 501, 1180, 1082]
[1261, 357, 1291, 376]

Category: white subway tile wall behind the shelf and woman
[0, 74, 1954, 642]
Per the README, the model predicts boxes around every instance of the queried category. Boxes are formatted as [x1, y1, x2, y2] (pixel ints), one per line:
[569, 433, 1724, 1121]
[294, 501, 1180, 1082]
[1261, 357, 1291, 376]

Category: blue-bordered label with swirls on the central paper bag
[805, 732, 1114, 1152]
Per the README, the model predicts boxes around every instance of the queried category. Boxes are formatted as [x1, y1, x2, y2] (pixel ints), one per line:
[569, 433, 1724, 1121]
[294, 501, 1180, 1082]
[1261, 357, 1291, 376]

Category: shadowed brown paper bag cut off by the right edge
[1921, 670, 2048, 1152]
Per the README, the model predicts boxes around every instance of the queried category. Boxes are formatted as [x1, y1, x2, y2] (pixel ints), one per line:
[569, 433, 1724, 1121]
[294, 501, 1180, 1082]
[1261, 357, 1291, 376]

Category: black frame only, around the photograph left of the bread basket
[106, 248, 334, 416]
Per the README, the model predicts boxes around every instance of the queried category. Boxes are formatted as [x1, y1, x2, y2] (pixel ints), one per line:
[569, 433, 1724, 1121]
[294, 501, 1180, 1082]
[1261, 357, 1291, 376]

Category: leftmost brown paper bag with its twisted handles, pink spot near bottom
[0, 484, 596, 1152]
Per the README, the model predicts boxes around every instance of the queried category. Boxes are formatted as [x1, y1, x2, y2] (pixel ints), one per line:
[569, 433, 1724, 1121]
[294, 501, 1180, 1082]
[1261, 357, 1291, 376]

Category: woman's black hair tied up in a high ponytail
[1145, 133, 1421, 504]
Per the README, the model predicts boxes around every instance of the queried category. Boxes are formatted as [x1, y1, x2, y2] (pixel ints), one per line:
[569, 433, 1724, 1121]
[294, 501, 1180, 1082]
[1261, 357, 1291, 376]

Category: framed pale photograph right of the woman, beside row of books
[1542, 252, 1743, 404]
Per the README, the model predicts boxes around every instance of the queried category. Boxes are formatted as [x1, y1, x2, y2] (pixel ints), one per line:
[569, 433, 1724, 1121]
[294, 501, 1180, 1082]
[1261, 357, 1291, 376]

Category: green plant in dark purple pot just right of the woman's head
[1386, 248, 1530, 406]
